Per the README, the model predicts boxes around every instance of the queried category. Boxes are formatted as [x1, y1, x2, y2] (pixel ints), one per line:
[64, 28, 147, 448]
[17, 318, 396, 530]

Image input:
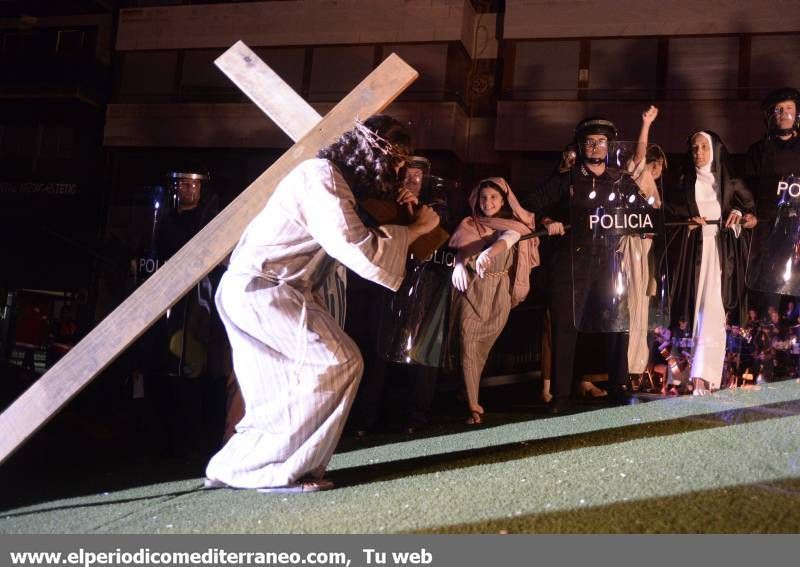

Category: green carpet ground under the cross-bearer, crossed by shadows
[0, 380, 800, 533]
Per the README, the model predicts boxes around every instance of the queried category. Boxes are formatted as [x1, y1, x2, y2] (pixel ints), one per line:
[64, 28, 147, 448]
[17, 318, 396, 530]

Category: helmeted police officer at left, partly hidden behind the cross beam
[139, 165, 230, 458]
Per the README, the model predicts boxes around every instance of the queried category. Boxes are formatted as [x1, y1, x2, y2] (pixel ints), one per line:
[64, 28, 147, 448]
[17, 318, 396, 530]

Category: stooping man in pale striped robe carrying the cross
[206, 115, 439, 492]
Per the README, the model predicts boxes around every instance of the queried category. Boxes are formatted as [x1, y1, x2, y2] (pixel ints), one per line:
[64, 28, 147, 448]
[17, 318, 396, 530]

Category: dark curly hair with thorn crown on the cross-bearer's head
[317, 114, 411, 199]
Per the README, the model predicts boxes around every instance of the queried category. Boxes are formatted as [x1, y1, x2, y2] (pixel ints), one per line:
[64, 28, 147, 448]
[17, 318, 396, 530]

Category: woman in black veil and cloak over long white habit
[668, 131, 756, 395]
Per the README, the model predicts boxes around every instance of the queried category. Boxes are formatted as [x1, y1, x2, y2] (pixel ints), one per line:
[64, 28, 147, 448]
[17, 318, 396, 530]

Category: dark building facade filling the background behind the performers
[0, 0, 800, 430]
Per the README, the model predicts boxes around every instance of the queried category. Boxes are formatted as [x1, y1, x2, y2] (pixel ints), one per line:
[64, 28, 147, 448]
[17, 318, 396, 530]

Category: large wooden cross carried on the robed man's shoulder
[0, 42, 417, 463]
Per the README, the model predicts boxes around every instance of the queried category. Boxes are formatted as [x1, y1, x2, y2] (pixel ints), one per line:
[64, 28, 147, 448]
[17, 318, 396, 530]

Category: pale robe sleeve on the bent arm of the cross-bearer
[296, 161, 409, 291]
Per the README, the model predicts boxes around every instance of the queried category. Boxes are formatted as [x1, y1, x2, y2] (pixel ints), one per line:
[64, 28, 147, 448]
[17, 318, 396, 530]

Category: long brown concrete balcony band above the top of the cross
[117, 0, 473, 51]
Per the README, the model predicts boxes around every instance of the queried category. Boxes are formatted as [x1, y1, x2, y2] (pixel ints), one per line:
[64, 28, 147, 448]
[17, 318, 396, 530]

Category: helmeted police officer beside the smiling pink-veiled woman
[523, 118, 638, 413]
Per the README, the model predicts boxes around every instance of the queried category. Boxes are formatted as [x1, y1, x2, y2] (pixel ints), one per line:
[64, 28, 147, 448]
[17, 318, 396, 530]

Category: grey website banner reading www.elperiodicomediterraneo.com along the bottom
[0, 535, 800, 567]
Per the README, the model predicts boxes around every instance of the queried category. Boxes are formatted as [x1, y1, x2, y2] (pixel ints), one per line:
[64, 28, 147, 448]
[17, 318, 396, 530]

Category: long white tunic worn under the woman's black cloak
[691, 179, 726, 390]
